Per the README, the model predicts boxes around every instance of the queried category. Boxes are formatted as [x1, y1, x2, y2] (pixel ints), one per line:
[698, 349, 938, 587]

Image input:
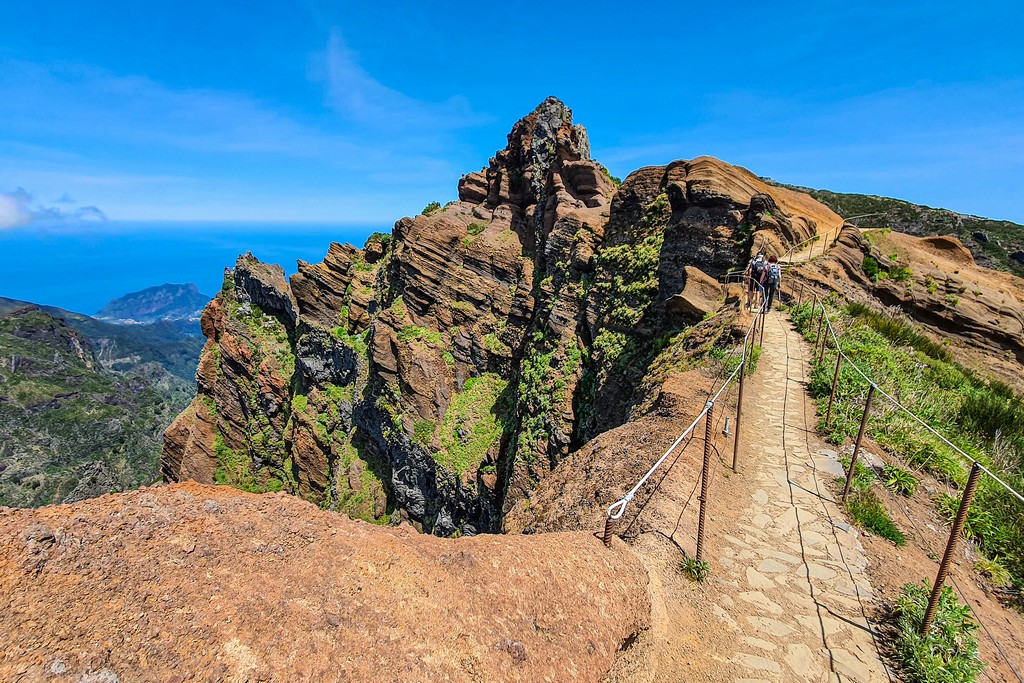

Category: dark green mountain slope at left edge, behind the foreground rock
[0, 306, 189, 506]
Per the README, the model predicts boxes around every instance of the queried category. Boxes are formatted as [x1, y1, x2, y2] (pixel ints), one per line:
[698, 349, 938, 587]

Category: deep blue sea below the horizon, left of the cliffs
[0, 221, 380, 315]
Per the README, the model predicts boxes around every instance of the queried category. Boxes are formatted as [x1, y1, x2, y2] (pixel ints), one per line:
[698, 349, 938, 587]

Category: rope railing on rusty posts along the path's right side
[808, 293, 1024, 638]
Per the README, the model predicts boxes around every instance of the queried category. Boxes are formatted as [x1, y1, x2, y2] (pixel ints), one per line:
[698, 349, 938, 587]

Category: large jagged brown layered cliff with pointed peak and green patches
[163, 98, 841, 535]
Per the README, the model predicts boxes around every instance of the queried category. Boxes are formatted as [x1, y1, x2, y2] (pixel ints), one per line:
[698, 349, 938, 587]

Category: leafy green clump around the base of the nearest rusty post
[889, 582, 985, 683]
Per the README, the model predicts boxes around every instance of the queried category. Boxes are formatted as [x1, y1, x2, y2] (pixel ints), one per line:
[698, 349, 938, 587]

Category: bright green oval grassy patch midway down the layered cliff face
[435, 373, 508, 475]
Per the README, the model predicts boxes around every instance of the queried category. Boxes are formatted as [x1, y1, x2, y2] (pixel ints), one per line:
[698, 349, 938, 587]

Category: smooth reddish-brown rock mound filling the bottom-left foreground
[0, 483, 649, 683]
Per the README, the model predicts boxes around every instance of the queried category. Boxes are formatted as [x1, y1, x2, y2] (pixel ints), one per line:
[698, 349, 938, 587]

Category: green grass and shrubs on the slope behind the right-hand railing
[793, 300, 1024, 586]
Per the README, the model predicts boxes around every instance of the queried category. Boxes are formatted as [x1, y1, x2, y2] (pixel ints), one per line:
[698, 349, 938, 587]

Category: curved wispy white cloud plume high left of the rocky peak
[323, 29, 489, 131]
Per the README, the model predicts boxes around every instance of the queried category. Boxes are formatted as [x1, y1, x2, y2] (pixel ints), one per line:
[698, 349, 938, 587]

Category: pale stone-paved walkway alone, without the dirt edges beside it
[711, 312, 892, 683]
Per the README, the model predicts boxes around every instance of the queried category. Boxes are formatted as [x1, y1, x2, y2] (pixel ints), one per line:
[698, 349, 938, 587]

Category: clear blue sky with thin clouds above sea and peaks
[0, 0, 1024, 229]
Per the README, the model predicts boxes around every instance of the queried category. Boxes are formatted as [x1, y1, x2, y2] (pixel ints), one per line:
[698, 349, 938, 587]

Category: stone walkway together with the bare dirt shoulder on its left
[612, 312, 895, 683]
